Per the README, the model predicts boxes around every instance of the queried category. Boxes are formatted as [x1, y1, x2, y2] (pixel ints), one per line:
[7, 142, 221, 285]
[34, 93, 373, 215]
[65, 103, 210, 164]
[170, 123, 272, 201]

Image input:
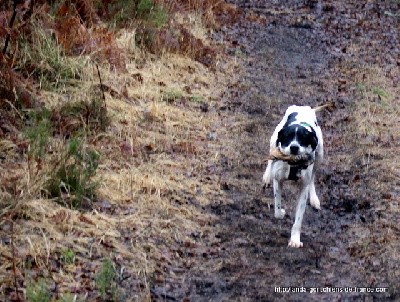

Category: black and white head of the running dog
[276, 112, 318, 155]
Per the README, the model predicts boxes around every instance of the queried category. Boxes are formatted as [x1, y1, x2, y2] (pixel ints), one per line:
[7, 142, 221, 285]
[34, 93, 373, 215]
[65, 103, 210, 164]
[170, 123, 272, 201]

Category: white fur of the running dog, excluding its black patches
[263, 105, 324, 247]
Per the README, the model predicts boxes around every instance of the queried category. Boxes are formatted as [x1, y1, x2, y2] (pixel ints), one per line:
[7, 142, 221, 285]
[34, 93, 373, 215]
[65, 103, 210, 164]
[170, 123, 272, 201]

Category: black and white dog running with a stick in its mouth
[263, 106, 324, 247]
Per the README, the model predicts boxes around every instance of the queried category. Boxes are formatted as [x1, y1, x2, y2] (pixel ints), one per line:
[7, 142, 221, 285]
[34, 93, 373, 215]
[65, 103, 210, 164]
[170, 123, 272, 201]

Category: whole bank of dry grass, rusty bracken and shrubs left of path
[0, 0, 238, 301]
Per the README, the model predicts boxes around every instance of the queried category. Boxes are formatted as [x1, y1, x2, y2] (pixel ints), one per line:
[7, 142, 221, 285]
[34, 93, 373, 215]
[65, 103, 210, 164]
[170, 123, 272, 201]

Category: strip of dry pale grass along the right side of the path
[349, 66, 400, 291]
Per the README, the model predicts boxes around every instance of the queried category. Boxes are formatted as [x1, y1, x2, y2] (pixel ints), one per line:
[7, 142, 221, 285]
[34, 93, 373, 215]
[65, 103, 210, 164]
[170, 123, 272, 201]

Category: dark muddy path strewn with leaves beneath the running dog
[176, 1, 398, 301]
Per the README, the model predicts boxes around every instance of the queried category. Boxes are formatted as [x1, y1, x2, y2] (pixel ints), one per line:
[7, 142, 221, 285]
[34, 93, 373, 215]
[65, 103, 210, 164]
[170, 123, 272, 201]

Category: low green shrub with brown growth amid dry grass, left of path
[25, 96, 107, 208]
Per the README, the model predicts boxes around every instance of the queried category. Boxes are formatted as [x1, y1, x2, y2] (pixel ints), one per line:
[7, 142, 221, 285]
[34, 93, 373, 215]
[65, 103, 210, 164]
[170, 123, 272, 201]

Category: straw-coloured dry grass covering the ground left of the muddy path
[0, 9, 241, 301]
